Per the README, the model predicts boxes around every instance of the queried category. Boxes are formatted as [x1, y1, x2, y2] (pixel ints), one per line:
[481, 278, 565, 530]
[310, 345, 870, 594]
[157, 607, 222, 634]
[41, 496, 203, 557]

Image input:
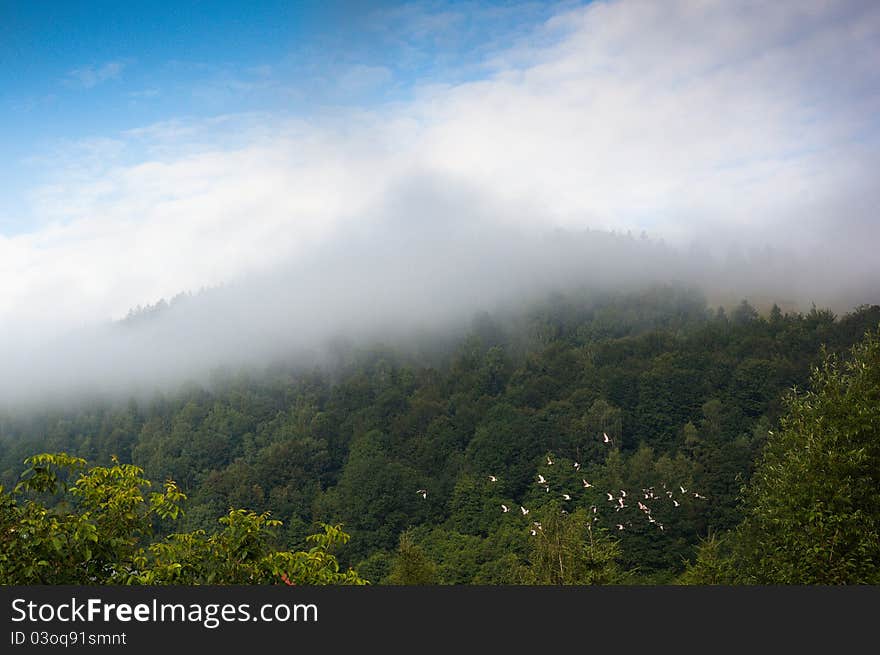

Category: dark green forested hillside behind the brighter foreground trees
[0, 287, 880, 583]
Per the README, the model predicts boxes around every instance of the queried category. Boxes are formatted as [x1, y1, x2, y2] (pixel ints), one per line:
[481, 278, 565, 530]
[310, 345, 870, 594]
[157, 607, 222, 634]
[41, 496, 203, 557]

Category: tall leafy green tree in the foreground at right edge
[738, 332, 880, 584]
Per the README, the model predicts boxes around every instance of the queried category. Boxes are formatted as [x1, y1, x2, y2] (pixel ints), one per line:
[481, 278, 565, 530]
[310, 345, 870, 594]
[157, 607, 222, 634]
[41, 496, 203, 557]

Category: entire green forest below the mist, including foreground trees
[0, 286, 880, 585]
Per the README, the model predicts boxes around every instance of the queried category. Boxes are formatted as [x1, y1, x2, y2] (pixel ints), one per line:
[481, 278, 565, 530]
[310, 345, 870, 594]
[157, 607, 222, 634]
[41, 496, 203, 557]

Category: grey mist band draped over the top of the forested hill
[0, 200, 880, 406]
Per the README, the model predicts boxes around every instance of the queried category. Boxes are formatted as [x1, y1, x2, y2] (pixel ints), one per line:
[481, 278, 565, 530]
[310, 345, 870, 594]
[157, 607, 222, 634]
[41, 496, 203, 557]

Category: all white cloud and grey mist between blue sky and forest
[0, 2, 880, 398]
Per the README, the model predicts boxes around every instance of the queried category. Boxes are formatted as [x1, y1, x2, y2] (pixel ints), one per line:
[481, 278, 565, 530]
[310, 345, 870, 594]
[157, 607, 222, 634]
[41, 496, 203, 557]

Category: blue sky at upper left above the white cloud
[0, 0, 575, 235]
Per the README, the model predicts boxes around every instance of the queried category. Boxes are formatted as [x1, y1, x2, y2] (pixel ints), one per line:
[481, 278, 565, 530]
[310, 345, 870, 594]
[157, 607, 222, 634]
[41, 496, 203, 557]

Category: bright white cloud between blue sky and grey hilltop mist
[0, 1, 880, 374]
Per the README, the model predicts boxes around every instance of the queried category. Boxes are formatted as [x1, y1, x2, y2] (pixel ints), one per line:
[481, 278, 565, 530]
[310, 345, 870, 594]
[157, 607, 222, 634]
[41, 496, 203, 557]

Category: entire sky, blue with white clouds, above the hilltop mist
[0, 0, 880, 402]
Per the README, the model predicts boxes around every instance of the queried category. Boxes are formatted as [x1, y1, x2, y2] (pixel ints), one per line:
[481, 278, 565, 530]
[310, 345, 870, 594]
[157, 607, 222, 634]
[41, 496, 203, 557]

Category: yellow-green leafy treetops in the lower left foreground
[0, 453, 365, 585]
